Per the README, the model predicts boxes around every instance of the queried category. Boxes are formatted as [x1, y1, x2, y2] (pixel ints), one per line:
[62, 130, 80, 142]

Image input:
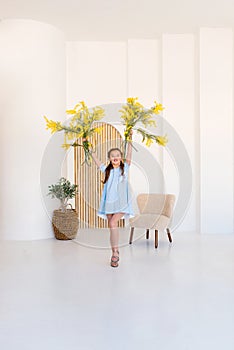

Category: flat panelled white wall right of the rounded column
[67, 28, 233, 233]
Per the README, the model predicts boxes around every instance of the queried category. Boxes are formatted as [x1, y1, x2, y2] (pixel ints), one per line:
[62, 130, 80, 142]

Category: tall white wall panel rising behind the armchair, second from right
[162, 34, 199, 231]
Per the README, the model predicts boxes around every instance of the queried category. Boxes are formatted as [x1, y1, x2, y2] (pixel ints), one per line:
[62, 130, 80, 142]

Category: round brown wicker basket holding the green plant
[52, 209, 78, 240]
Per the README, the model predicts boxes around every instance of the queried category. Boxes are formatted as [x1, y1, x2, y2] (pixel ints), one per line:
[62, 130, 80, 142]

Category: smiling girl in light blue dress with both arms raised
[92, 132, 134, 267]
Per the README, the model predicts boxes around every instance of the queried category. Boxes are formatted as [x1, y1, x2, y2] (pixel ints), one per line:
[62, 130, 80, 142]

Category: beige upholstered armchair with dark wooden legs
[129, 193, 175, 248]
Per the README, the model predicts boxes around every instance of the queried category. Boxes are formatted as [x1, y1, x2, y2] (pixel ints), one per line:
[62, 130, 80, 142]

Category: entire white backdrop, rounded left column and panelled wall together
[0, 20, 233, 239]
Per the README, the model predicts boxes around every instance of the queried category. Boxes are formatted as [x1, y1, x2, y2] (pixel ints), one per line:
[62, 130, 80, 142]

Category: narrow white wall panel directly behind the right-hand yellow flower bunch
[127, 39, 164, 198]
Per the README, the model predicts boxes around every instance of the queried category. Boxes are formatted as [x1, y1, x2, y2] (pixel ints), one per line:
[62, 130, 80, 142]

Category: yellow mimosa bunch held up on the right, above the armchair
[120, 97, 168, 154]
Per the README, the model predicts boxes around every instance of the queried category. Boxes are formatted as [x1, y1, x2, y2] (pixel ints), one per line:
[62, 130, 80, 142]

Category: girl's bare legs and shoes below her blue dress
[107, 213, 124, 266]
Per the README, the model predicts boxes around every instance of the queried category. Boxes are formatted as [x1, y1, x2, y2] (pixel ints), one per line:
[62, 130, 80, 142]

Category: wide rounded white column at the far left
[0, 20, 66, 240]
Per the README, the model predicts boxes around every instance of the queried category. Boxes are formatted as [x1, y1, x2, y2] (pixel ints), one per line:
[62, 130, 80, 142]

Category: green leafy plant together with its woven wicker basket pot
[48, 177, 78, 240]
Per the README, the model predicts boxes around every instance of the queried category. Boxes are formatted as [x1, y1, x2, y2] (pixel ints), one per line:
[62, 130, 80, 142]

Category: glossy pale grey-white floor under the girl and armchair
[0, 230, 234, 350]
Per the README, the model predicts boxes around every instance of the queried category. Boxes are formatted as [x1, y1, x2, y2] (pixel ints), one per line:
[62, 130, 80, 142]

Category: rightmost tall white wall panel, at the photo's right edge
[200, 28, 233, 233]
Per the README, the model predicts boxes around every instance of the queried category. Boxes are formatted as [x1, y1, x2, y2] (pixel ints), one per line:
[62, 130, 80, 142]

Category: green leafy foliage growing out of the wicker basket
[48, 177, 78, 212]
